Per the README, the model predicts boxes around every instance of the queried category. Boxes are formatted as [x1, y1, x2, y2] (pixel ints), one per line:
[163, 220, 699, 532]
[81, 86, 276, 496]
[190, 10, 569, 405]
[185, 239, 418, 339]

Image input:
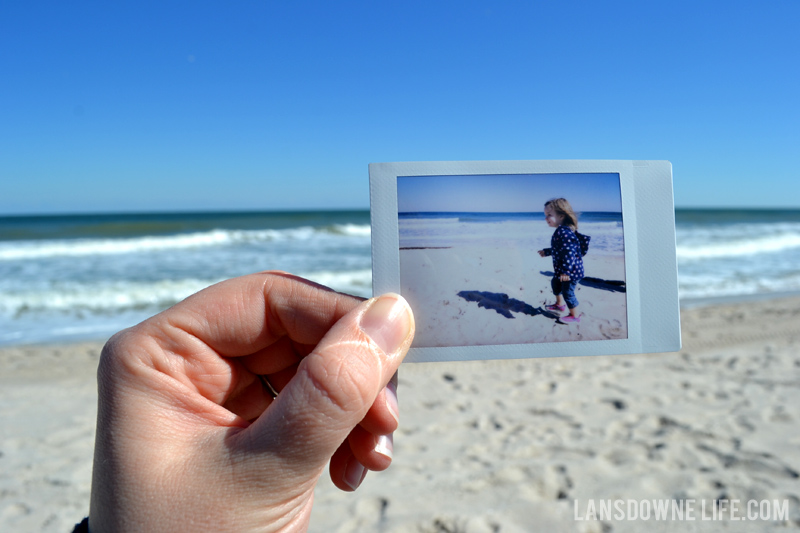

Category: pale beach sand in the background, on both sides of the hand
[0, 298, 800, 533]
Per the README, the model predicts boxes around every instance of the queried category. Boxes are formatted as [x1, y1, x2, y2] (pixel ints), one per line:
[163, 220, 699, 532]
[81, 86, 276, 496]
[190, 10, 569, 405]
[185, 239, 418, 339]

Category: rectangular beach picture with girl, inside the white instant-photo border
[397, 173, 628, 348]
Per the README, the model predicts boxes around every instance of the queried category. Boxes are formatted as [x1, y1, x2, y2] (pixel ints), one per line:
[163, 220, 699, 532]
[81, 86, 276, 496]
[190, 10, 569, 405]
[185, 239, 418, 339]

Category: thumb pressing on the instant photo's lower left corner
[250, 294, 414, 467]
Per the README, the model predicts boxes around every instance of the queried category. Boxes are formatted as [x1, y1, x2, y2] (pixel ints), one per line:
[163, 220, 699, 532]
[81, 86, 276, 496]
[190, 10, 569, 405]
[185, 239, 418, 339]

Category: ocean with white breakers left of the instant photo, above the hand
[0, 211, 372, 345]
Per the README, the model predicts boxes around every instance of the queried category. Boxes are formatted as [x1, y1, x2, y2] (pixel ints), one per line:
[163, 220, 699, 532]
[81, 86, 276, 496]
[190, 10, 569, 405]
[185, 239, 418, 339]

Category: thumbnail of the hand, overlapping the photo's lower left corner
[359, 294, 413, 354]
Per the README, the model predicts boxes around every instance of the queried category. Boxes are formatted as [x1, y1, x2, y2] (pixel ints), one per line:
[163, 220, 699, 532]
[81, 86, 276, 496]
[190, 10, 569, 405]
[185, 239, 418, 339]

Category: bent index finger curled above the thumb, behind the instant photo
[134, 273, 360, 405]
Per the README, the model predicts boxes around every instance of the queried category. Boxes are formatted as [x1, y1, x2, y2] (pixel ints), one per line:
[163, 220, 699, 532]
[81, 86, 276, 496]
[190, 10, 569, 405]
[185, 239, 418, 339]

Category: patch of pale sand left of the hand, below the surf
[0, 343, 101, 532]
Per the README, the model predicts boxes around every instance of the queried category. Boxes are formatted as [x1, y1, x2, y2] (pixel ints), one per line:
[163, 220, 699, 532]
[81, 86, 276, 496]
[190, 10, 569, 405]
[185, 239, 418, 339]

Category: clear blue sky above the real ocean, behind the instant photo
[0, 0, 800, 215]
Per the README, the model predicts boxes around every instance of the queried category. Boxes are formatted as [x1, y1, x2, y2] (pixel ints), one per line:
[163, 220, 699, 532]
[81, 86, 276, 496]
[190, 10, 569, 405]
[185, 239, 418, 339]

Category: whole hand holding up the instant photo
[89, 273, 414, 533]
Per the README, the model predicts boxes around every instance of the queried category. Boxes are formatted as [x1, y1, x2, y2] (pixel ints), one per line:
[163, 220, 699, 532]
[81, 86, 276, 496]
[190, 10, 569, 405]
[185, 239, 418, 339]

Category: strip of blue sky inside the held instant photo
[397, 174, 622, 213]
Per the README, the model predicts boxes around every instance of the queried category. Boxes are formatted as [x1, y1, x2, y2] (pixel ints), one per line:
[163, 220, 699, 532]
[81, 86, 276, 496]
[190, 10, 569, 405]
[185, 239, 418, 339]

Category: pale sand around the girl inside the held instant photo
[400, 247, 628, 347]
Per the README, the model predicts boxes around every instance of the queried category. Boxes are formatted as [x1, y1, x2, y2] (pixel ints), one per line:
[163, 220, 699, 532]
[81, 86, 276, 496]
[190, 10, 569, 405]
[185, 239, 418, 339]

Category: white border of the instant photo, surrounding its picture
[369, 160, 681, 362]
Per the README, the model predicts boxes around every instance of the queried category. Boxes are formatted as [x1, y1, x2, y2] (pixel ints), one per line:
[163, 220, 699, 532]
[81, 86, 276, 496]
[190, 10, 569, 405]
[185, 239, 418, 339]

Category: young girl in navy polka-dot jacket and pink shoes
[539, 198, 583, 323]
